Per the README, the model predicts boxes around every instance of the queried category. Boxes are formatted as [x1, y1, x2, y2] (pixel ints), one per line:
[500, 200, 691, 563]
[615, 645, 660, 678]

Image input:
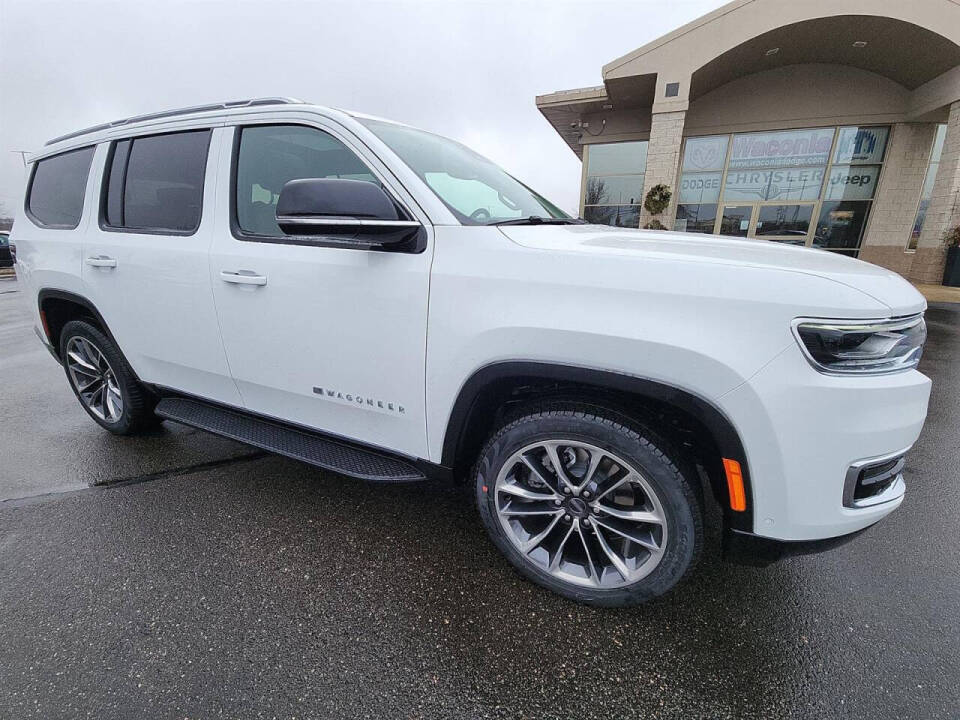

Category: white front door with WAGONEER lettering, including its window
[210, 123, 433, 457]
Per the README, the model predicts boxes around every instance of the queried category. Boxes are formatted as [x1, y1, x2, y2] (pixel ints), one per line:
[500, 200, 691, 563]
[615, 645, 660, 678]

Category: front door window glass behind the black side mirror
[233, 125, 380, 237]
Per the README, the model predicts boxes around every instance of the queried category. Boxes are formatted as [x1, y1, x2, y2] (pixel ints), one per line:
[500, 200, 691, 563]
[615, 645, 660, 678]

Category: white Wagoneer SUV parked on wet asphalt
[14, 98, 930, 605]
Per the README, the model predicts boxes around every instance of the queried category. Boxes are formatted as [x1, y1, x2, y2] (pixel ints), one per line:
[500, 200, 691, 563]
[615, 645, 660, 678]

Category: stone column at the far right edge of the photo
[910, 100, 960, 285]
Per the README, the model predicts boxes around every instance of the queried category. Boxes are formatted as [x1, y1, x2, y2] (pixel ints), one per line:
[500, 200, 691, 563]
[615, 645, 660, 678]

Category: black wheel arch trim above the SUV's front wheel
[441, 361, 753, 532]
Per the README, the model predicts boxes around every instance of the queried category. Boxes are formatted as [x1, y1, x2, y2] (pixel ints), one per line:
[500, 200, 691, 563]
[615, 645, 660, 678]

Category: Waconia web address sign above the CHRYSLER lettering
[729, 128, 835, 169]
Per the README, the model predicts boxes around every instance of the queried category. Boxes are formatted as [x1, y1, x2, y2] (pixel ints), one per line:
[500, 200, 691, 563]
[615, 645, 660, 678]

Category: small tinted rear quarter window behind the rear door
[27, 146, 93, 229]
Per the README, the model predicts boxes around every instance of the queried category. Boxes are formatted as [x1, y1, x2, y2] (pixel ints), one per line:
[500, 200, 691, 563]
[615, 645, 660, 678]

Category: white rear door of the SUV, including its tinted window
[83, 127, 240, 405]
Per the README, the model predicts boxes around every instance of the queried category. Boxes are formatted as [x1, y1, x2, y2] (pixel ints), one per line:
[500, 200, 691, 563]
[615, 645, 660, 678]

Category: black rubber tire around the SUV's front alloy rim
[474, 402, 703, 607]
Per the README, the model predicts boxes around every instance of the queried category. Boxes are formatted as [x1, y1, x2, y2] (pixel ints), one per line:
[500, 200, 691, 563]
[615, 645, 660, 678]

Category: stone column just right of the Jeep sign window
[859, 123, 937, 277]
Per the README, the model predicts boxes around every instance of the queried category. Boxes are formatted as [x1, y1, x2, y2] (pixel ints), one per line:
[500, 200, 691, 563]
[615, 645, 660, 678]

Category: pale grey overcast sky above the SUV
[0, 0, 723, 217]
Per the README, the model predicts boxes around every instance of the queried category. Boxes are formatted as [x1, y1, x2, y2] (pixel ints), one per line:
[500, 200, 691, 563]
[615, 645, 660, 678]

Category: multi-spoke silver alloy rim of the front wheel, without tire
[494, 440, 668, 589]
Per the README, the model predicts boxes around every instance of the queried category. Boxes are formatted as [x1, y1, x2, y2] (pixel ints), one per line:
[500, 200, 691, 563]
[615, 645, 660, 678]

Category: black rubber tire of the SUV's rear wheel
[60, 320, 160, 435]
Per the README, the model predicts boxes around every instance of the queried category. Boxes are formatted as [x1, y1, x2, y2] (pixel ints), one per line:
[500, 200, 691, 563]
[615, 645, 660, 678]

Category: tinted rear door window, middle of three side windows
[103, 130, 210, 234]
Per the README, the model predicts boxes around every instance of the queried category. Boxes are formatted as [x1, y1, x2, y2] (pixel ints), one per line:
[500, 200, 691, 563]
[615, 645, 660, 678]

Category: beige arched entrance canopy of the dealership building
[537, 0, 960, 153]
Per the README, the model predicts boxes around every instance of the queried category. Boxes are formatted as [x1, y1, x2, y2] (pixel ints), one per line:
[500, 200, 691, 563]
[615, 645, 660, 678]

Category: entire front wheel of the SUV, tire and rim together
[476, 403, 703, 606]
